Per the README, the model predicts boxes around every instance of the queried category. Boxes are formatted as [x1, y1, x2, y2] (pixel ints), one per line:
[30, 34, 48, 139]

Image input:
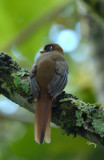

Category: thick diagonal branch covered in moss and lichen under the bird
[0, 53, 104, 146]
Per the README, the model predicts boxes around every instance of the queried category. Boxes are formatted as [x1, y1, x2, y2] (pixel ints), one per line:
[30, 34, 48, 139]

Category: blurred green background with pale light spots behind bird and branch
[0, 0, 104, 160]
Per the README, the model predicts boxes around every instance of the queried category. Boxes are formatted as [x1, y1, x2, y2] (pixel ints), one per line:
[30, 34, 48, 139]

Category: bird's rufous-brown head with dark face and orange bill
[40, 43, 64, 54]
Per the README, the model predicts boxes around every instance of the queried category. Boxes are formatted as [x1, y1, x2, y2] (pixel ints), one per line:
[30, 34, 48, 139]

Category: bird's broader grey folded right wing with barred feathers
[48, 63, 68, 97]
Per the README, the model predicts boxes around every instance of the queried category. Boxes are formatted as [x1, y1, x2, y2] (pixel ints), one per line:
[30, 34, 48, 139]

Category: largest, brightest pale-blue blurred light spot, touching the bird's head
[49, 22, 81, 52]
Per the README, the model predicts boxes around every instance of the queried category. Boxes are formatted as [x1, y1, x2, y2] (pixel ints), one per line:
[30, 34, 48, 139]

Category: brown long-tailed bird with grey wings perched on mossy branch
[30, 43, 68, 144]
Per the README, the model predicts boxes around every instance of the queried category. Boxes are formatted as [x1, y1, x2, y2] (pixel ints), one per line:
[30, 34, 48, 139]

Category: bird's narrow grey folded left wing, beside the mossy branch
[30, 65, 40, 97]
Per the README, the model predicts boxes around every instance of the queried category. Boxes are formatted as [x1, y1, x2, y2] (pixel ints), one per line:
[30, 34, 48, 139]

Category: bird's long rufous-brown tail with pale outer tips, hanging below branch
[35, 98, 52, 144]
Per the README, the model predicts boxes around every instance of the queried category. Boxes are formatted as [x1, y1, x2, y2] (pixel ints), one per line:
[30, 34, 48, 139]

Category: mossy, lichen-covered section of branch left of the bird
[0, 52, 35, 111]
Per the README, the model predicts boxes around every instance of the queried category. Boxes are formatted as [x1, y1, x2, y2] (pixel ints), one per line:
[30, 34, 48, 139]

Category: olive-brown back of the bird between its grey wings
[36, 59, 55, 92]
